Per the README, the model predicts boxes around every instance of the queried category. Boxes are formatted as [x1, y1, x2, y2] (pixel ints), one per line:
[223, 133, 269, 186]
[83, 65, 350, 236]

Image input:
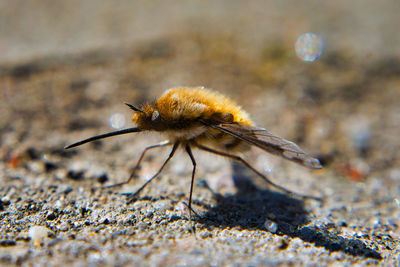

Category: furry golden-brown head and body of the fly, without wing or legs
[132, 87, 253, 150]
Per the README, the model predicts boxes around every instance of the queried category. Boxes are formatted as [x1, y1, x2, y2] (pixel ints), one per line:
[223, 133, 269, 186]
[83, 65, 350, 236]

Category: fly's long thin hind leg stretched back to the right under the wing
[193, 142, 321, 201]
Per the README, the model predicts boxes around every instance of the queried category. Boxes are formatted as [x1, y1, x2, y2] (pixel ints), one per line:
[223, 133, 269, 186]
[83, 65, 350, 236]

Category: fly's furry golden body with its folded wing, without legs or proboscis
[132, 87, 321, 169]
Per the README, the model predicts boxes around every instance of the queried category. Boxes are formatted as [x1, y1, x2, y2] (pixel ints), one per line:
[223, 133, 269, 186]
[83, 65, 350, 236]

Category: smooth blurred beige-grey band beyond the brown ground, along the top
[0, 0, 400, 63]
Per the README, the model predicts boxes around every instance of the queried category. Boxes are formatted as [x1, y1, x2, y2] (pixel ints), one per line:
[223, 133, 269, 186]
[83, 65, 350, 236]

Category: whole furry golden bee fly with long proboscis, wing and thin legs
[65, 87, 322, 215]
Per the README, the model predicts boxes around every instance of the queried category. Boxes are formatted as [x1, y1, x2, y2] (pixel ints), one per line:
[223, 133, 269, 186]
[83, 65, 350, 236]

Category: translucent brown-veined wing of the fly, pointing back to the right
[207, 124, 322, 169]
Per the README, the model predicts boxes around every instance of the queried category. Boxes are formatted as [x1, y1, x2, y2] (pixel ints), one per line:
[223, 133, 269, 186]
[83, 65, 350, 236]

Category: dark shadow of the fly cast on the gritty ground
[198, 163, 382, 260]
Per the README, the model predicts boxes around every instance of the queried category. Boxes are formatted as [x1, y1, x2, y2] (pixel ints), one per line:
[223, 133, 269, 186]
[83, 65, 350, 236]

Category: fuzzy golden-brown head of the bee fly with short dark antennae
[125, 103, 164, 131]
